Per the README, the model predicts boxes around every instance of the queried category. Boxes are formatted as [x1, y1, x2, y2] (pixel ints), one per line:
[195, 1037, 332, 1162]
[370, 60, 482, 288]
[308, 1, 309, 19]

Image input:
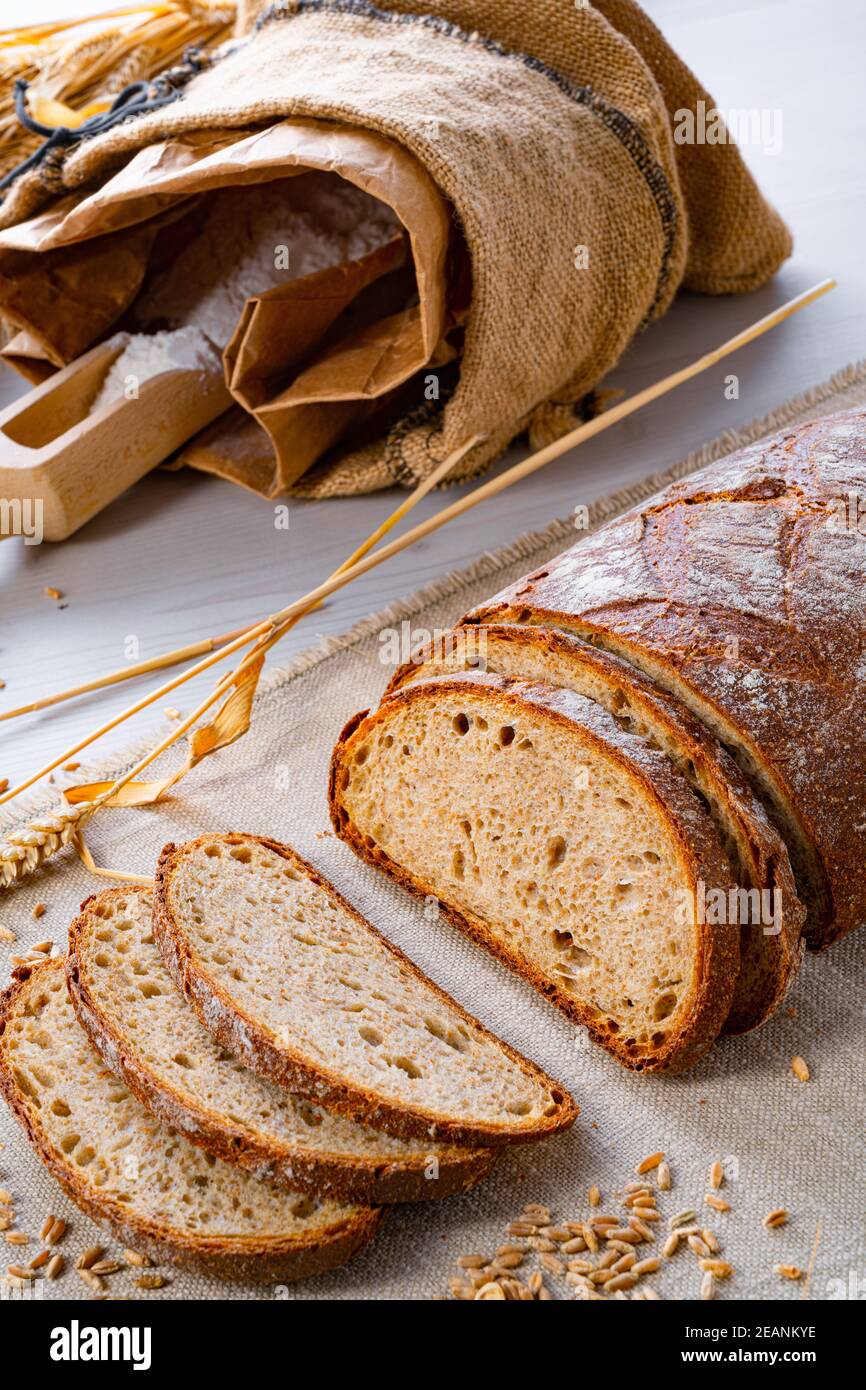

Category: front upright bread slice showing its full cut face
[331, 673, 740, 1072]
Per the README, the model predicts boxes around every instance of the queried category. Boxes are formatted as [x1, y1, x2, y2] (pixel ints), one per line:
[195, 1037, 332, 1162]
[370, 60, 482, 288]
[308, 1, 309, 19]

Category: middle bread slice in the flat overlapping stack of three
[67, 888, 495, 1205]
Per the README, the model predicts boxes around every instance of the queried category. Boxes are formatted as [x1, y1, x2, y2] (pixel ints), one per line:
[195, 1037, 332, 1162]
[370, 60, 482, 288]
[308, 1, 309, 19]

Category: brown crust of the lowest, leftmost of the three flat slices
[0, 956, 384, 1282]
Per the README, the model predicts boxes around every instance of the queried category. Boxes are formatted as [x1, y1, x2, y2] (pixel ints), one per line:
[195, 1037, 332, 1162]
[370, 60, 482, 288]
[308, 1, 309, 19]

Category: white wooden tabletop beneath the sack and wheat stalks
[0, 0, 866, 780]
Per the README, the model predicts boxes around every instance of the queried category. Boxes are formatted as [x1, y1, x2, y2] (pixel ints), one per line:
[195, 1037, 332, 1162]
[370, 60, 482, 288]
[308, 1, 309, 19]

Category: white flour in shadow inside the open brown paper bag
[135, 172, 400, 349]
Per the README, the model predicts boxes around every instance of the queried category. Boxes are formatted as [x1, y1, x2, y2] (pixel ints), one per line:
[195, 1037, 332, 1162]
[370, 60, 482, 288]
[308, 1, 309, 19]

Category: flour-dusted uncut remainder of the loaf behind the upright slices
[466, 411, 866, 949]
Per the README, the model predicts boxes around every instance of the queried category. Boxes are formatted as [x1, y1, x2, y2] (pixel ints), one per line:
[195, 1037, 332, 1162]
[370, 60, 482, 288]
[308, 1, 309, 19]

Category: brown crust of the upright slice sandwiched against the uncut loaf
[384, 623, 805, 1034]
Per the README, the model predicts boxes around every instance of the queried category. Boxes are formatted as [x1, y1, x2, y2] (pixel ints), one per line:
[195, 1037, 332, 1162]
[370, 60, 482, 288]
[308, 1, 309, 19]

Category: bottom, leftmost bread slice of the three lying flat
[0, 959, 382, 1280]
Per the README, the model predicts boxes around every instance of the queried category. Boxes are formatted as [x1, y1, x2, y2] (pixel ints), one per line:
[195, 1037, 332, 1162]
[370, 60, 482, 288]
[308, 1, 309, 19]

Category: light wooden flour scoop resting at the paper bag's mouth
[0, 334, 232, 541]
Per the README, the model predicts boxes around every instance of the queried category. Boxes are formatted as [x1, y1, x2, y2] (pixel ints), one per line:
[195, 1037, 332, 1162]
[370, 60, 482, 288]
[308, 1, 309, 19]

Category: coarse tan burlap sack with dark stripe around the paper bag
[4, 0, 790, 496]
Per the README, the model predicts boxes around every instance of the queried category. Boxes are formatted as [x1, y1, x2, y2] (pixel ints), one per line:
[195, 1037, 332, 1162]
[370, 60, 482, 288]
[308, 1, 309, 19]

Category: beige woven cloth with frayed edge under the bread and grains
[0, 363, 866, 1300]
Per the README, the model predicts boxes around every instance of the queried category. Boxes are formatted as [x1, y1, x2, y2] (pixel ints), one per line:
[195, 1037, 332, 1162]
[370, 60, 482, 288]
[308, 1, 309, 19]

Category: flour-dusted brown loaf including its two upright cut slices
[331, 413, 866, 1069]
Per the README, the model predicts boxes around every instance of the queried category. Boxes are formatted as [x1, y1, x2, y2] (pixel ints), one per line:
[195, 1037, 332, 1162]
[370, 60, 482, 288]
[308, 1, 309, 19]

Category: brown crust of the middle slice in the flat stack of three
[67, 888, 498, 1207]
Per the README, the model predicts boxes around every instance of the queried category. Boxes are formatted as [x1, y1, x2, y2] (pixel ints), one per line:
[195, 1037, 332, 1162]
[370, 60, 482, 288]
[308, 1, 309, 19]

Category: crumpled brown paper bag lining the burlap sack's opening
[0, 122, 450, 496]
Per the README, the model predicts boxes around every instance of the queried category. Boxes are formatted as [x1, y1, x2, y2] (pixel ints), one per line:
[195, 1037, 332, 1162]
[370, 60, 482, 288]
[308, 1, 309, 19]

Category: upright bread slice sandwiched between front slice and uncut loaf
[388, 624, 806, 1033]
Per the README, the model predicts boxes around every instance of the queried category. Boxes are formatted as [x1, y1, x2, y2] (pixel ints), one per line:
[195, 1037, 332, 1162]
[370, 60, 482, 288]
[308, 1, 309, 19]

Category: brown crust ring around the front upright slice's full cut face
[328, 674, 740, 1073]
